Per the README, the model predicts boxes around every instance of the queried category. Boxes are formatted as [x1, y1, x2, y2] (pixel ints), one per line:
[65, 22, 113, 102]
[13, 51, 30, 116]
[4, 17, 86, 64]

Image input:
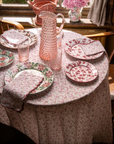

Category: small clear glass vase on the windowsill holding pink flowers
[68, 7, 82, 22]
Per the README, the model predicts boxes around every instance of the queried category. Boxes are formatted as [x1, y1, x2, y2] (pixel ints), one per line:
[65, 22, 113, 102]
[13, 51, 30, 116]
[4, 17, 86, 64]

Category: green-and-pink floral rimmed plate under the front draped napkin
[5, 62, 54, 94]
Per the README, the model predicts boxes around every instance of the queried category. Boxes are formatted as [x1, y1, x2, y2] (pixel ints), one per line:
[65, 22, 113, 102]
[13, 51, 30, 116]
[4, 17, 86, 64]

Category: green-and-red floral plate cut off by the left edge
[0, 49, 14, 68]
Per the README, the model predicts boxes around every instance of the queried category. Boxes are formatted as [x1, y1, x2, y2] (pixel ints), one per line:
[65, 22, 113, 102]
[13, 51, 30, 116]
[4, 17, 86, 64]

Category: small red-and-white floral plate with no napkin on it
[65, 61, 98, 83]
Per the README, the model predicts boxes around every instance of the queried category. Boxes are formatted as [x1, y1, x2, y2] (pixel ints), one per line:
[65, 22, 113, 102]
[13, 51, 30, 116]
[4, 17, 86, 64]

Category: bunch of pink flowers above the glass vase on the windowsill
[63, 0, 90, 9]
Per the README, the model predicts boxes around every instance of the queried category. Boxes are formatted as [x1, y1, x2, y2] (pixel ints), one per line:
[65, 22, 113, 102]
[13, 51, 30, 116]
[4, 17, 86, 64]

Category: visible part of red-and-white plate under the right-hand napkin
[65, 39, 103, 60]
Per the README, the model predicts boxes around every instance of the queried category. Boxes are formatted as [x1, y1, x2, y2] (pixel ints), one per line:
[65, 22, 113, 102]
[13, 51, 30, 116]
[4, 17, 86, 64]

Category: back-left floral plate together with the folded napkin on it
[0, 29, 37, 49]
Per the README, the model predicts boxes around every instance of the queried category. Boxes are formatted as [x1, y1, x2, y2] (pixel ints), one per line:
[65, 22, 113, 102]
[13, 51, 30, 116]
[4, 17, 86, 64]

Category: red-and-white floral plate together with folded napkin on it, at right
[65, 37, 105, 60]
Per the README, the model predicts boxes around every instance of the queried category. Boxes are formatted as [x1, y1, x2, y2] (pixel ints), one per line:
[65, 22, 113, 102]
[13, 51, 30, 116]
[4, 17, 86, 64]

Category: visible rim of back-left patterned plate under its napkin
[0, 30, 37, 49]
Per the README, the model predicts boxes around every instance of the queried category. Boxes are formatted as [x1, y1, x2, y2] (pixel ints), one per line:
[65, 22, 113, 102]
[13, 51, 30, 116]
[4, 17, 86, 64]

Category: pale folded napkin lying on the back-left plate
[1, 29, 28, 45]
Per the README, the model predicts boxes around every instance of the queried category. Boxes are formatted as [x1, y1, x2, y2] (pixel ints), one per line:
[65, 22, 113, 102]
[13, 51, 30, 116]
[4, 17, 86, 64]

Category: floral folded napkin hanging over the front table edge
[1, 71, 43, 111]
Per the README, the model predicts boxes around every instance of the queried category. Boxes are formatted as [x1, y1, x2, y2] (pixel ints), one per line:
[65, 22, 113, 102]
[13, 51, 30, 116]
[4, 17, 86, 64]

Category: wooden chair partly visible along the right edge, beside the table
[85, 31, 114, 100]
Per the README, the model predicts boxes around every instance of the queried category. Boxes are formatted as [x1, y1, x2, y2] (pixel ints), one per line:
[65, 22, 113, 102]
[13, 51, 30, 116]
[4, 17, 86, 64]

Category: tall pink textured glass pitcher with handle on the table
[39, 11, 65, 60]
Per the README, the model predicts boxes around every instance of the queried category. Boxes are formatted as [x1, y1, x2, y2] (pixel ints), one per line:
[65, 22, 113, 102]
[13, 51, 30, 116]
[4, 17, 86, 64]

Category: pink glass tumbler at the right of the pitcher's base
[50, 47, 62, 70]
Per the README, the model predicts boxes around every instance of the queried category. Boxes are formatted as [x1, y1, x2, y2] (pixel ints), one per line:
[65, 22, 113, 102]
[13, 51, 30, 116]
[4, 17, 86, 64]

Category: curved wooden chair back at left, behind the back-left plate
[0, 20, 24, 34]
